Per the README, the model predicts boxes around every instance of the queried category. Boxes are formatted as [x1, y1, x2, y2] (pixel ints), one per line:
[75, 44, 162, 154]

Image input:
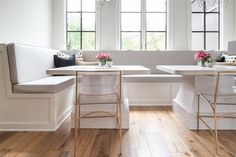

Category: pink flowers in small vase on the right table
[194, 50, 214, 66]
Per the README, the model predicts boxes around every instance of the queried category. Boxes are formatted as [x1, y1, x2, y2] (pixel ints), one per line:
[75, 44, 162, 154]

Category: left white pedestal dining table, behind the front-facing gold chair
[47, 65, 151, 129]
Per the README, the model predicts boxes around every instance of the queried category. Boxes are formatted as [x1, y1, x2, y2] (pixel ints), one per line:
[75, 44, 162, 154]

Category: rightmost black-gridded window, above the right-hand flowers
[192, 0, 221, 50]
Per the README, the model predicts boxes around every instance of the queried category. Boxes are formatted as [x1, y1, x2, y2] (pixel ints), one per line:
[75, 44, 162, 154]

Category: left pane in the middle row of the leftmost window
[67, 13, 80, 31]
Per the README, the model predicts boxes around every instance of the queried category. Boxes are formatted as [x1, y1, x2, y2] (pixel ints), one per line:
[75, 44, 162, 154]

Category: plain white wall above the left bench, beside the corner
[0, 0, 52, 48]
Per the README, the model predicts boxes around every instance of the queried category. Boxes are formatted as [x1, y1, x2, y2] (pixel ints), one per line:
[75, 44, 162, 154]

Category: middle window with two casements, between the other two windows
[120, 0, 167, 50]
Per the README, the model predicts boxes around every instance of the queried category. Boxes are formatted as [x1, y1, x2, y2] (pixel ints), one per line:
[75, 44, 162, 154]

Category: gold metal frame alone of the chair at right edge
[197, 71, 236, 154]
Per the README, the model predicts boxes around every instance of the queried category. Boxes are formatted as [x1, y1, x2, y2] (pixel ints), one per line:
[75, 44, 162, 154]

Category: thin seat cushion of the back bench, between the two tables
[123, 74, 182, 82]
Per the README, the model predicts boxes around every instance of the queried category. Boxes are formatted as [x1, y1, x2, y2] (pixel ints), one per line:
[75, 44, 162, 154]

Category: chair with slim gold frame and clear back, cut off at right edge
[197, 71, 236, 154]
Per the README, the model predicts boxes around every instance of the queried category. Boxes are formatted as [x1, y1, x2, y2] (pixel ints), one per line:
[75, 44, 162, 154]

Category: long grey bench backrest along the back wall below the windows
[64, 50, 230, 74]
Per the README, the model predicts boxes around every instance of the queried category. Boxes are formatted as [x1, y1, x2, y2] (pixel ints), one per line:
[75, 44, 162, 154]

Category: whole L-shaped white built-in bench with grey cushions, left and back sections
[0, 44, 234, 131]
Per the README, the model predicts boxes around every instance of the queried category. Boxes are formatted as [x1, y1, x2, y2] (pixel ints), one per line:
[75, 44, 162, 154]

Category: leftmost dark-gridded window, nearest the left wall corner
[66, 0, 96, 50]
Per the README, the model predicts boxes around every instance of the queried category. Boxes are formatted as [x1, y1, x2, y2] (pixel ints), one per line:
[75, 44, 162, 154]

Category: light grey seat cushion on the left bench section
[13, 76, 74, 93]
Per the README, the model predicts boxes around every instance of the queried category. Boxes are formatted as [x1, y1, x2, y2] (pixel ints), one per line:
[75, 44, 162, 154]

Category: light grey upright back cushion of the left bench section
[7, 44, 57, 84]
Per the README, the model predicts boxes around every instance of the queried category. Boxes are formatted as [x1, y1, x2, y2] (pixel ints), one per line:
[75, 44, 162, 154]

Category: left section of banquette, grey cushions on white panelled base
[0, 44, 74, 131]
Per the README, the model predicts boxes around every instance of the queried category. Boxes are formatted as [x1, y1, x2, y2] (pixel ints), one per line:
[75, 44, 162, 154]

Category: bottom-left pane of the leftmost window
[67, 32, 80, 50]
